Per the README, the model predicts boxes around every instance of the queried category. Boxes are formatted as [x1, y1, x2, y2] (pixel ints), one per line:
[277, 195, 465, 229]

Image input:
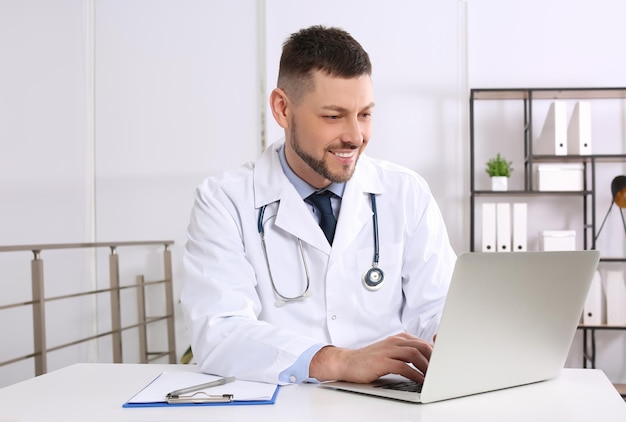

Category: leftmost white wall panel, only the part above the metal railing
[0, 0, 92, 244]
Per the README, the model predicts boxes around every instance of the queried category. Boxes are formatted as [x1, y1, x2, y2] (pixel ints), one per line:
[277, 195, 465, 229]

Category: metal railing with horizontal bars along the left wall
[0, 240, 176, 375]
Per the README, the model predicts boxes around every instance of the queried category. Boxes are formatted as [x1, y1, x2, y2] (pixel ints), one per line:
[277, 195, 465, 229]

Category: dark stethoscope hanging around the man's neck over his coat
[257, 193, 385, 306]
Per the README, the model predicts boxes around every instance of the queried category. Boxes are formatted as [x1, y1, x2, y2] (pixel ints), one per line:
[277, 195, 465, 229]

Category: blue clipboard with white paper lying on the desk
[122, 371, 279, 408]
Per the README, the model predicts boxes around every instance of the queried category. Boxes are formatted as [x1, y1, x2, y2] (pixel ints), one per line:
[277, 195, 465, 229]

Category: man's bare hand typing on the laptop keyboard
[309, 333, 433, 383]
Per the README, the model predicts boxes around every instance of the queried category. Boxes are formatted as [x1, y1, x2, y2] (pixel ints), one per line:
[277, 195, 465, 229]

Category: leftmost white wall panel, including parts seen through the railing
[0, 0, 93, 385]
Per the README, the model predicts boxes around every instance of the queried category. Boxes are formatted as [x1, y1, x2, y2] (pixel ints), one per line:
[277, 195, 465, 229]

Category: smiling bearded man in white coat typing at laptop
[181, 26, 456, 384]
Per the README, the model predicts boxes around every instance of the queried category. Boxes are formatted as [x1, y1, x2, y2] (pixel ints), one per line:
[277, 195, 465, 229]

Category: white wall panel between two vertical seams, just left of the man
[95, 0, 260, 362]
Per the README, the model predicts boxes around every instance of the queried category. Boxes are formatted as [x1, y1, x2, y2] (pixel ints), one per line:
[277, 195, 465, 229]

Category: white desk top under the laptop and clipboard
[0, 364, 626, 422]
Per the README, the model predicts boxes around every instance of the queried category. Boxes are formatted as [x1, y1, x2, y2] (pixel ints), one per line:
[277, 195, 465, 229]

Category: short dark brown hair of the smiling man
[277, 25, 372, 102]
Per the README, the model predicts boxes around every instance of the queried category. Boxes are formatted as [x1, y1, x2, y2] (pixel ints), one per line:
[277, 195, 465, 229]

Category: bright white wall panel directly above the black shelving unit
[468, 0, 626, 88]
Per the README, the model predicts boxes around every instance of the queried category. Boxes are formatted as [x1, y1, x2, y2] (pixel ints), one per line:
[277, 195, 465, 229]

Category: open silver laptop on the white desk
[321, 251, 600, 403]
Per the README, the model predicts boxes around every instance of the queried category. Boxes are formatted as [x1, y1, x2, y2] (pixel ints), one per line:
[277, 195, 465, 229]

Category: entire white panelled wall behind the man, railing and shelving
[0, 0, 626, 384]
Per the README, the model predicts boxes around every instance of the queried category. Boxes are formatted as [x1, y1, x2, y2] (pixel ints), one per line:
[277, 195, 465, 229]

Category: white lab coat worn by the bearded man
[181, 142, 456, 383]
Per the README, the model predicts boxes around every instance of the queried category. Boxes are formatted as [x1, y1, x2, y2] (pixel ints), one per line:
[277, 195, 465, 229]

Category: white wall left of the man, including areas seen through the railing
[0, 0, 260, 385]
